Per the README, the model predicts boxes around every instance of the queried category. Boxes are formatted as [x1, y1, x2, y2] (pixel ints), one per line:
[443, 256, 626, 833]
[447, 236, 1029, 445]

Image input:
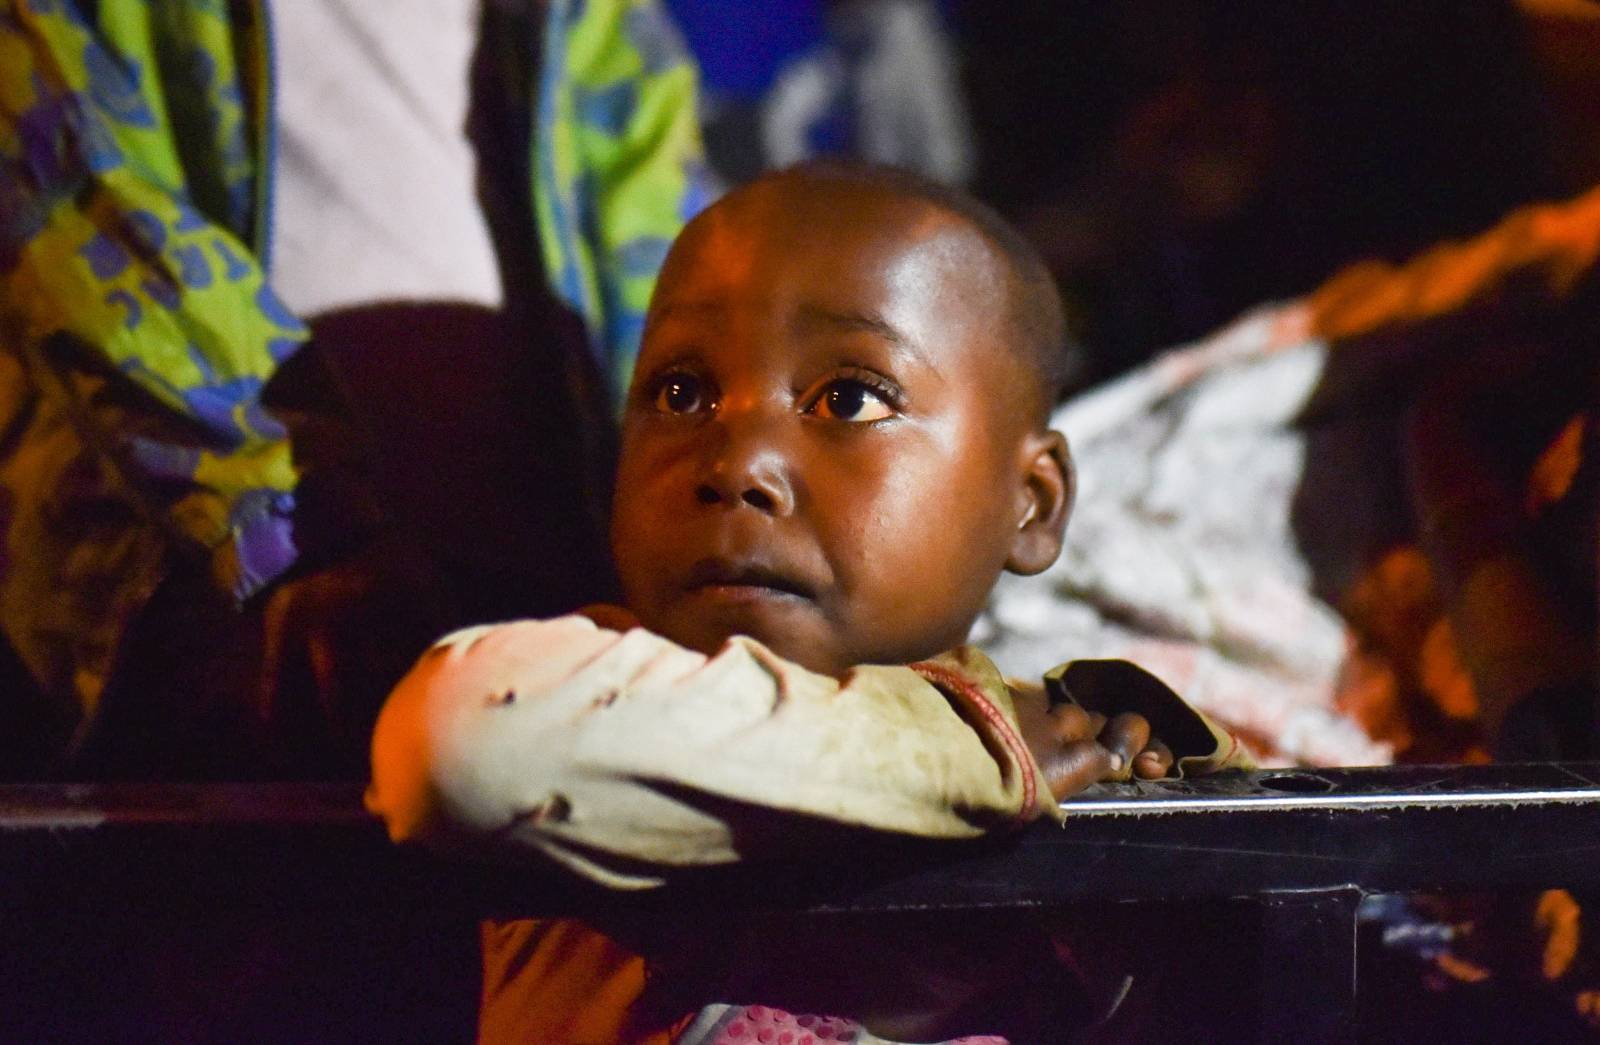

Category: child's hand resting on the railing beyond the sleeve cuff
[1018, 701, 1173, 799]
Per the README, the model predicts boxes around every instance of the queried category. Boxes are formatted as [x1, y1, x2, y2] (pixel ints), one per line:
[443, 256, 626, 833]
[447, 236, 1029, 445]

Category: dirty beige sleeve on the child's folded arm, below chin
[366, 616, 1054, 887]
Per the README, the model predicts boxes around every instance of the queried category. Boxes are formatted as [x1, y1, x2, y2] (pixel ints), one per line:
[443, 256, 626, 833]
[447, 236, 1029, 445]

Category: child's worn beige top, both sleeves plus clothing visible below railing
[368, 616, 1250, 1043]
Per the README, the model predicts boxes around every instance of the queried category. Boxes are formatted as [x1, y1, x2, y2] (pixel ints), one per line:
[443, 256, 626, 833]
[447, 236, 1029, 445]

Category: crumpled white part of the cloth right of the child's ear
[974, 306, 1392, 765]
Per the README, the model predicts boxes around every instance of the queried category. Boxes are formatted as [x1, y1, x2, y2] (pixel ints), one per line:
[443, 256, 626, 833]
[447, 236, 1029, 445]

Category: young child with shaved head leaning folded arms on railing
[370, 165, 1243, 1042]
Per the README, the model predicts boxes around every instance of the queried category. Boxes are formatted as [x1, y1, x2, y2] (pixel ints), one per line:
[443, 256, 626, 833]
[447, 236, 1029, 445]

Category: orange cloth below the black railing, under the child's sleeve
[478, 919, 693, 1045]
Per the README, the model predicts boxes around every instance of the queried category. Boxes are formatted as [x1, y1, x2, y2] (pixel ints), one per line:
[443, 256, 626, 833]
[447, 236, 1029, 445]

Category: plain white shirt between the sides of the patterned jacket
[269, 0, 504, 315]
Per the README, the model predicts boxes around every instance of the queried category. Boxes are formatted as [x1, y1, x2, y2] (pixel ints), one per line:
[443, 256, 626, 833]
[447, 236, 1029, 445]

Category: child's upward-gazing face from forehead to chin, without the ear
[611, 182, 1037, 674]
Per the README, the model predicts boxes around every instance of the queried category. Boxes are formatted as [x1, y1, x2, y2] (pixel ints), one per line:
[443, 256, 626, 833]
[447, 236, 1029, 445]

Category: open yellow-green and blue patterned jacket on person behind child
[0, 0, 709, 742]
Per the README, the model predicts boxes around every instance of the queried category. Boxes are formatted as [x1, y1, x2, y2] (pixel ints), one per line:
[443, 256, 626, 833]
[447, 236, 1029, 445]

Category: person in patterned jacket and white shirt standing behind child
[0, 0, 709, 778]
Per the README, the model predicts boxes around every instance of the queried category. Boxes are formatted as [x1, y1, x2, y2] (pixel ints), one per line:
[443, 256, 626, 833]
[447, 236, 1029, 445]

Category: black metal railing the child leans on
[0, 763, 1600, 1040]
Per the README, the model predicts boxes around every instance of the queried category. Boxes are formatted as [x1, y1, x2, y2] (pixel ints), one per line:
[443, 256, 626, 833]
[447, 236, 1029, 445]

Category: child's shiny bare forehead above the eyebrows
[646, 179, 1008, 358]
